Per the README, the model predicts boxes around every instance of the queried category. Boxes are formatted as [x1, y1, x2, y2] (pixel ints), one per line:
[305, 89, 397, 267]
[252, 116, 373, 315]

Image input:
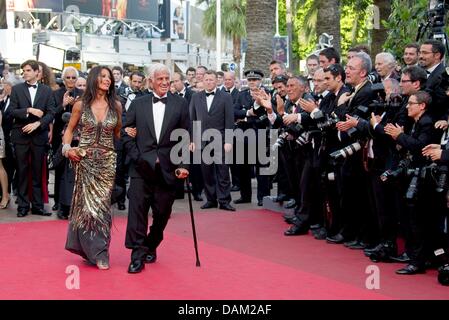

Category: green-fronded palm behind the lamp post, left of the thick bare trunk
[198, 0, 246, 63]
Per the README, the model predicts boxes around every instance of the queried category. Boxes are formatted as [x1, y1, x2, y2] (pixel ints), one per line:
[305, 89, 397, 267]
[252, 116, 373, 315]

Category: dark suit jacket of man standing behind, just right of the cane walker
[189, 89, 234, 143]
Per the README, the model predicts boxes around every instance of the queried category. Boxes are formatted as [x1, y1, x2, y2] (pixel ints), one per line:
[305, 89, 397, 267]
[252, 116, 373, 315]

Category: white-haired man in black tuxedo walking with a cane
[122, 64, 189, 273]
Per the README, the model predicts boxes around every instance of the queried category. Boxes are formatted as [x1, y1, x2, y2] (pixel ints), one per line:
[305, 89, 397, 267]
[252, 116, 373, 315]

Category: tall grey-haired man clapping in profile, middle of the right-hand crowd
[326, 52, 376, 249]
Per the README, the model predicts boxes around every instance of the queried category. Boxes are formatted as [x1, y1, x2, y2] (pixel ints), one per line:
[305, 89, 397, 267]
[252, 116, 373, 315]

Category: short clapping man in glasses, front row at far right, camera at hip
[385, 91, 441, 275]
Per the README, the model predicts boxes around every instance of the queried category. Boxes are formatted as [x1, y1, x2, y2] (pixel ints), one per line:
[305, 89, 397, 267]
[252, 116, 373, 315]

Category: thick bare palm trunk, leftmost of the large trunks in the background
[245, 0, 276, 75]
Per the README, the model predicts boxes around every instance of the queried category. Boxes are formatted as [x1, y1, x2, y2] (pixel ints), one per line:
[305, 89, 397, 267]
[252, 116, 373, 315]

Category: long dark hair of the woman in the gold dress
[83, 66, 118, 117]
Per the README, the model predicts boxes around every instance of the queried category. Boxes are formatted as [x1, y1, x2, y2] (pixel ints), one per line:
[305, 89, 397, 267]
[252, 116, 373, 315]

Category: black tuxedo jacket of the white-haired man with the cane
[122, 93, 190, 185]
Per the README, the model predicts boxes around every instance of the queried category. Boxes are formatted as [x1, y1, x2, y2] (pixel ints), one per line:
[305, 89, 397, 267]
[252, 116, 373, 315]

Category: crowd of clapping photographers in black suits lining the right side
[256, 40, 449, 281]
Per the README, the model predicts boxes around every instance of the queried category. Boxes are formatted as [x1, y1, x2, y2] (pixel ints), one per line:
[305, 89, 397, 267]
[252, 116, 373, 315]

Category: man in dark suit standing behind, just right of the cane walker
[189, 70, 235, 211]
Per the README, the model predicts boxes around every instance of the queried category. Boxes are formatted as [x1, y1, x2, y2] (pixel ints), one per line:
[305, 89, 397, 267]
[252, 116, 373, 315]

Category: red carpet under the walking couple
[0, 210, 449, 300]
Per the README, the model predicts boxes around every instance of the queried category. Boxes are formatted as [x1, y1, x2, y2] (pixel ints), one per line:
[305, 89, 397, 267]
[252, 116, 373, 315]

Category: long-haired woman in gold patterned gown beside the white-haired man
[62, 66, 121, 269]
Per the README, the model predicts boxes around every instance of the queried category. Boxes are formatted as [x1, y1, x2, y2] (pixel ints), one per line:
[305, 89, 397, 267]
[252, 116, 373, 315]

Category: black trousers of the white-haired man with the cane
[125, 166, 175, 261]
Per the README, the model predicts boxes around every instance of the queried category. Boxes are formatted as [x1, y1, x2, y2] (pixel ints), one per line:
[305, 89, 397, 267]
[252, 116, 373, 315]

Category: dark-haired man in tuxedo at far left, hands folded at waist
[9, 60, 55, 217]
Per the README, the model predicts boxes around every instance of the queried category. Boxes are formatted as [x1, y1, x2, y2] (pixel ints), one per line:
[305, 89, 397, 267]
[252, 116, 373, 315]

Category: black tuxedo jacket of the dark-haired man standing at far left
[9, 83, 56, 146]
